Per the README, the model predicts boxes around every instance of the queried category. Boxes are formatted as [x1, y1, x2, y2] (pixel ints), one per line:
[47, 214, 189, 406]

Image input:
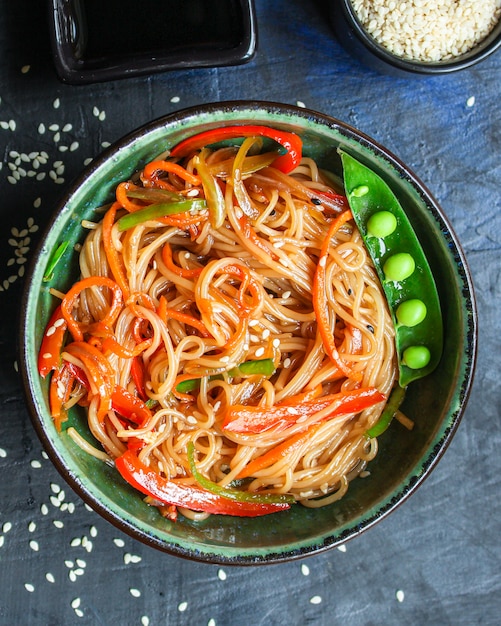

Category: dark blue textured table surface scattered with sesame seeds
[0, 0, 501, 626]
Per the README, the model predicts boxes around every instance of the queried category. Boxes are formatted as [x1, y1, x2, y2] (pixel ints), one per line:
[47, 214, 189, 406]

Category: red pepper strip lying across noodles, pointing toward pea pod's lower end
[222, 387, 386, 433]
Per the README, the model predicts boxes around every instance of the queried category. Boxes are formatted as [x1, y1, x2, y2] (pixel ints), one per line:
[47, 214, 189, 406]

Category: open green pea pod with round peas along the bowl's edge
[340, 151, 443, 387]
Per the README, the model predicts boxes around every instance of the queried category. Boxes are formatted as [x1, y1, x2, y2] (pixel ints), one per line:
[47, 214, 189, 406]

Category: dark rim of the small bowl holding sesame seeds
[338, 0, 501, 74]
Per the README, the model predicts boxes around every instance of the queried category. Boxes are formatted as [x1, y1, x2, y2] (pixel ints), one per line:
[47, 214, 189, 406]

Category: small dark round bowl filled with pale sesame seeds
[331, 0, 501, 74]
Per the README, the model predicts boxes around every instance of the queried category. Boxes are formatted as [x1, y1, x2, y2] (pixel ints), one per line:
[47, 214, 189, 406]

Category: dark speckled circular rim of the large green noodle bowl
[19, 100, 478, 565]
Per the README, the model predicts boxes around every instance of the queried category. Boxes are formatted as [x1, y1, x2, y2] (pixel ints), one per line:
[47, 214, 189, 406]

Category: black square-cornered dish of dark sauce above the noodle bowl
[49, 0, 256, 84]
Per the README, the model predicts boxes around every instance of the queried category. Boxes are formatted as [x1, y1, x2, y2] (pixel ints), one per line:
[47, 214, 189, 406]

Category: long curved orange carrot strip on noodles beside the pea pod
[312, 210, 352, 376]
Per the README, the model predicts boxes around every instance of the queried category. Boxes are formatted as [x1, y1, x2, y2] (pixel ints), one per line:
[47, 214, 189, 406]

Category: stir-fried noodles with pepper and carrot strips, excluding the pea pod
[39, 126, 408, 519]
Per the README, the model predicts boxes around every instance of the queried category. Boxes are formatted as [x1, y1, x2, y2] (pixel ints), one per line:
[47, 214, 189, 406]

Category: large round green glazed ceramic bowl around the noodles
[20, 102, 476, 565]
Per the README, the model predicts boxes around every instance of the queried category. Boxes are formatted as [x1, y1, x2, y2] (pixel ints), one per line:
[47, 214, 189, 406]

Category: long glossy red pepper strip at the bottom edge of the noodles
[115, 451, 290, 517]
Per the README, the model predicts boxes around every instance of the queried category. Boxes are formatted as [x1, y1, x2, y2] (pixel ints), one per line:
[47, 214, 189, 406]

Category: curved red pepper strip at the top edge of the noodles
[170, 125, 303, 174]
